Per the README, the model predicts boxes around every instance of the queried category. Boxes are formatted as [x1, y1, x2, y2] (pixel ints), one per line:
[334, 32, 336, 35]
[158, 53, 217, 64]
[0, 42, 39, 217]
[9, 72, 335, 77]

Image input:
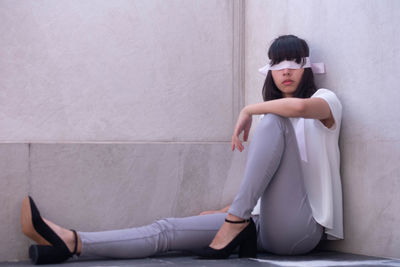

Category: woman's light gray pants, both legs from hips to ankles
[79, 114, 323, 258]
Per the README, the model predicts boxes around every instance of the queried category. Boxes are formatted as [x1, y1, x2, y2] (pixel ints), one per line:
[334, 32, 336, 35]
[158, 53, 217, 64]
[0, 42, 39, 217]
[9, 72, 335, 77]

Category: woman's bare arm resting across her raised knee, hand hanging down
[232, 97, 334, 152]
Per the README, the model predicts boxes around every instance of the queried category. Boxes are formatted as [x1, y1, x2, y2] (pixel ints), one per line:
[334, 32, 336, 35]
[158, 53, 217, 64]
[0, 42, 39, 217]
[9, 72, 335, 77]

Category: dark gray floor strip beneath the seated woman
[0, 251, 400, 267]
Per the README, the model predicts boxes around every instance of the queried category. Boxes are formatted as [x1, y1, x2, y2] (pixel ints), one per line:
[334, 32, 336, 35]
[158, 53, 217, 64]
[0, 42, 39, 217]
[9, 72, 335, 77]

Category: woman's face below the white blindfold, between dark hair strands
[271, 68, 304, 97]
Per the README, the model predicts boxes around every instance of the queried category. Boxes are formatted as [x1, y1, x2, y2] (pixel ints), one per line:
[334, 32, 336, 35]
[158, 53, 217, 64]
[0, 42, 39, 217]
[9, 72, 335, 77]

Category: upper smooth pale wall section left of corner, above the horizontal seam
[0, 0, 242, 142]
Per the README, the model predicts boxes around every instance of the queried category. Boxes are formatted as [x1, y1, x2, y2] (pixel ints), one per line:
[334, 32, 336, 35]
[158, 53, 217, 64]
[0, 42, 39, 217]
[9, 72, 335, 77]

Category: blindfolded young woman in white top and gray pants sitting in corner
[21, 35, 343, 264]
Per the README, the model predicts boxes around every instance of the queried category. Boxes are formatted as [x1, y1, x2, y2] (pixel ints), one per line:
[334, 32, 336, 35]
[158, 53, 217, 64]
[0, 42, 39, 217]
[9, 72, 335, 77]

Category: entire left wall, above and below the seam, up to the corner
[0, 0, 245, 261]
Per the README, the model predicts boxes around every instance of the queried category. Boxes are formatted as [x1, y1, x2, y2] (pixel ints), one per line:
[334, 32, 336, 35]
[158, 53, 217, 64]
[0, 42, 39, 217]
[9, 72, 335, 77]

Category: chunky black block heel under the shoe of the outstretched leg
[29, 245, 69, 265]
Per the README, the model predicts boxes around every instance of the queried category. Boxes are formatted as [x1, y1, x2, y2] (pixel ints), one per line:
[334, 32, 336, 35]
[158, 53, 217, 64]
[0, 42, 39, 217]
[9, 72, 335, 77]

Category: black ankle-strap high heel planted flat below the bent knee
[194, 218, 257, 259]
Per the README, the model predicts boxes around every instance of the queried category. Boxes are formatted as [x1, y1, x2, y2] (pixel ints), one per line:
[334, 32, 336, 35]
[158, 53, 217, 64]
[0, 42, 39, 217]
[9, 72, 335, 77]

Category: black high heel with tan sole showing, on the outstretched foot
[21, 196, 78, 264]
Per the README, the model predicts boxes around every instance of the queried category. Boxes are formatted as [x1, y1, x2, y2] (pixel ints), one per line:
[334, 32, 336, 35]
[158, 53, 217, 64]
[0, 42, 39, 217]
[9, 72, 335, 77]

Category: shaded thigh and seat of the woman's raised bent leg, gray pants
[255, 118, 323, 255]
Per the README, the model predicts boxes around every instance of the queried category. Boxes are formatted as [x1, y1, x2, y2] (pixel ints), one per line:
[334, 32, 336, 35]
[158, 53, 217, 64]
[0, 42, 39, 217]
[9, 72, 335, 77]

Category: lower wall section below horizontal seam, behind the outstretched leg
[0, 142, 246, 262]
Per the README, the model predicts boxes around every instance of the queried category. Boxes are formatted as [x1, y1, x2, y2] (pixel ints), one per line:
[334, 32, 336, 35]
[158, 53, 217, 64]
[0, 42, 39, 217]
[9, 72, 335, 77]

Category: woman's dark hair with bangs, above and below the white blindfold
[262, 35, 317, 101]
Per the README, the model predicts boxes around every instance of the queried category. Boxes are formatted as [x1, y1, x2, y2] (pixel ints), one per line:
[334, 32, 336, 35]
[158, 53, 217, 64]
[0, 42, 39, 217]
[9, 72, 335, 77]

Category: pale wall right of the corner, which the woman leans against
[245, 0, 400, 258]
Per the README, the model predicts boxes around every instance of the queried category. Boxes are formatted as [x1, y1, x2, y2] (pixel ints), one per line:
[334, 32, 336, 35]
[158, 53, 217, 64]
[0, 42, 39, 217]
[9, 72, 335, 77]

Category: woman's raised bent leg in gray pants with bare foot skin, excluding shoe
[211, 114, 322, 254]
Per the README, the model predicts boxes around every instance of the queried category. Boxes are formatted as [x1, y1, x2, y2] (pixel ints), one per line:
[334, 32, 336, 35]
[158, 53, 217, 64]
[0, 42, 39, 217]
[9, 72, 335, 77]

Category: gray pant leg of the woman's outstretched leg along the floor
[79, 213, 226, 258]
